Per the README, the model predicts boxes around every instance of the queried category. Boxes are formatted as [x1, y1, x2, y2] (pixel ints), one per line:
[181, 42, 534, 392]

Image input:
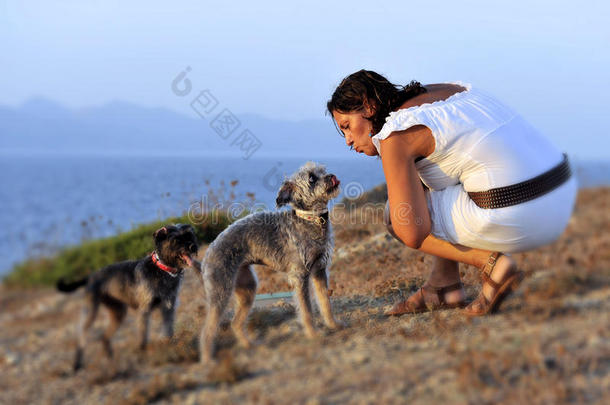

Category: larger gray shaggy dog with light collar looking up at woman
[200, 162, 339, 363]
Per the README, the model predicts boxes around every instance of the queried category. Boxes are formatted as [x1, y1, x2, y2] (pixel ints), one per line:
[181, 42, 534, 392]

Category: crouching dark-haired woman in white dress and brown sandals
[327, 70, 578, 316]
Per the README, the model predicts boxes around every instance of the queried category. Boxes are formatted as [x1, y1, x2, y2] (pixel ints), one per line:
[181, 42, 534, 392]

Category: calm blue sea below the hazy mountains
[0, 152, 610, 275]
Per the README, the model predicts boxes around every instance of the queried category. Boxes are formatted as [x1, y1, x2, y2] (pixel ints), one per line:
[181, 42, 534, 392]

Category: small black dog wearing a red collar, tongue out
[57, 224, 200, 371]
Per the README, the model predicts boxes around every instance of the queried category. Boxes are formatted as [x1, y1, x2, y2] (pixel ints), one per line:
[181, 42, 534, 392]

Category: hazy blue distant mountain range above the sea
[0, 98, 346, 157]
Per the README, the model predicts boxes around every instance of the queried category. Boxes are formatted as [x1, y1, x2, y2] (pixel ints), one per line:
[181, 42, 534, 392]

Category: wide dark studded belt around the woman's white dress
[468, 153, 571, 208]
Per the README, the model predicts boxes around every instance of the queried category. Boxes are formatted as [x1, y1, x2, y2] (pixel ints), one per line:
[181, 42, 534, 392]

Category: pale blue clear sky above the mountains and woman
[0, 0, 610, 160]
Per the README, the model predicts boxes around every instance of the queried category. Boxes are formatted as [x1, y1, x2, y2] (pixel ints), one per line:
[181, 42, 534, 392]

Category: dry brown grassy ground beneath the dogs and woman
[0, 188, 610, 404]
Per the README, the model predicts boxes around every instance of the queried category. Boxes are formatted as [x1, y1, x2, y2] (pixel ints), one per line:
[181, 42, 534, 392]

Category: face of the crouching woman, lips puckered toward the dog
[333, 105, 378, 156]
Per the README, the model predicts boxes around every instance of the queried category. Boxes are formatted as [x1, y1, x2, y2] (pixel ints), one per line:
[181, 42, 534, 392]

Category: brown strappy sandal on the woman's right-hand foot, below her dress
[463, 252, 525, 316]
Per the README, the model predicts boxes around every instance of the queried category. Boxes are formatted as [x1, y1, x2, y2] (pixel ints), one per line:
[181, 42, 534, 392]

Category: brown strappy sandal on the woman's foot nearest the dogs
[385, 282, 466, 316]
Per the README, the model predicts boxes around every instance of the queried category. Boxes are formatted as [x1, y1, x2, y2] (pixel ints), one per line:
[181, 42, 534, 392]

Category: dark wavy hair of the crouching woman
[326, 69, 426, 135]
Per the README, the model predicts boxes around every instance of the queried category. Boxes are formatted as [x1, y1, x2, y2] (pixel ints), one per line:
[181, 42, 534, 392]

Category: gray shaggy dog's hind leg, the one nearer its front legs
[231, 264, 257, 348]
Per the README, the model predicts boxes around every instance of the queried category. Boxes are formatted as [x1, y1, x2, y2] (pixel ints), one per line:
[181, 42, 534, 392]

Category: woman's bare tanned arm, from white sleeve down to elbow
[380, 125, 432, 249]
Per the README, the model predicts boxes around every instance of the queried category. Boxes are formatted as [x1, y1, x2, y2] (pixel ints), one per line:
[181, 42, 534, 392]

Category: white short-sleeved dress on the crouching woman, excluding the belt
[372, 82, 578, 253]
